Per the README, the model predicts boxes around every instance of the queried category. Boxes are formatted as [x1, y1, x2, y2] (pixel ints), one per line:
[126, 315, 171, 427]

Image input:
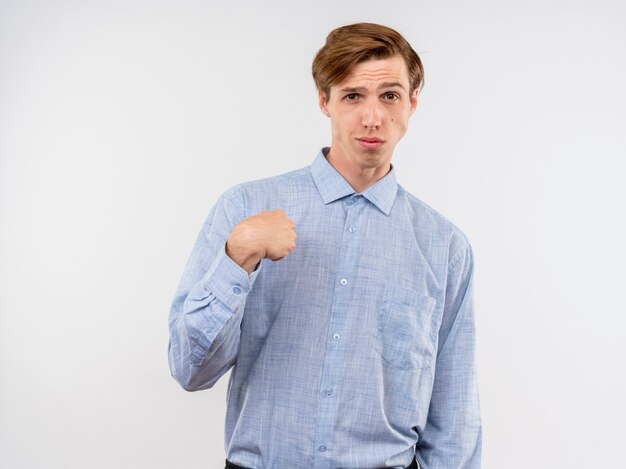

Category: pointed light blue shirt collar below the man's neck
[311, 148, 398, 215]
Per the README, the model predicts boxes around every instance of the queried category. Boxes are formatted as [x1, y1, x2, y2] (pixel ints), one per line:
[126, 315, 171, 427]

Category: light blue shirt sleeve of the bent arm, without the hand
[168, 190, 260, 391]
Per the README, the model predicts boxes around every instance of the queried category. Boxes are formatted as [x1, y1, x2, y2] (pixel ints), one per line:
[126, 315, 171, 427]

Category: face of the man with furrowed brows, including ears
[319, 56, 417, 175]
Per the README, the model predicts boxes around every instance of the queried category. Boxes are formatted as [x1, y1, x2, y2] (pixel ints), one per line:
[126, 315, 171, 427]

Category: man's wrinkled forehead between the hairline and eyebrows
[337, 55, 409, 90]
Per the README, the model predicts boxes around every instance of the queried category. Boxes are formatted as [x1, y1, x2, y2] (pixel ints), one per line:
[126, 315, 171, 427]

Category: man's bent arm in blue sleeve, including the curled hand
[168, 190, 295, 391]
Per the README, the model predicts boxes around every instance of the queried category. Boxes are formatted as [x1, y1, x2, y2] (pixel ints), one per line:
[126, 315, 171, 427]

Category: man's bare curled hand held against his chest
[226, 210, 296, 274]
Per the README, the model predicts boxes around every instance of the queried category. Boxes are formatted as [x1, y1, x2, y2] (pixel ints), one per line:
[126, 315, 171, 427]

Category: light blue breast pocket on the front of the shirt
[376, 287, 437, 370]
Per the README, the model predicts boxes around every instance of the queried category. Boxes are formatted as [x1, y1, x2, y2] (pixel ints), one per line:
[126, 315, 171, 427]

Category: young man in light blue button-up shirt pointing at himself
[169, 24, 481, 469]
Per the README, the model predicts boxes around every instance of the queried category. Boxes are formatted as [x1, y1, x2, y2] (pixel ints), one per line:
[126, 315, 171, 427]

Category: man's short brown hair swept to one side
[313, 23, 424, 99]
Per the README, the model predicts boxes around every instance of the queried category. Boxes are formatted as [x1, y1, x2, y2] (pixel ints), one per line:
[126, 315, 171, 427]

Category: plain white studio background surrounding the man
[0, 0, 626, 469]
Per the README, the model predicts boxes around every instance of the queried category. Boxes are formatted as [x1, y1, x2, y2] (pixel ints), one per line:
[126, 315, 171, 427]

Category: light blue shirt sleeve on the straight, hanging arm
[416, 239, 482, 469]
